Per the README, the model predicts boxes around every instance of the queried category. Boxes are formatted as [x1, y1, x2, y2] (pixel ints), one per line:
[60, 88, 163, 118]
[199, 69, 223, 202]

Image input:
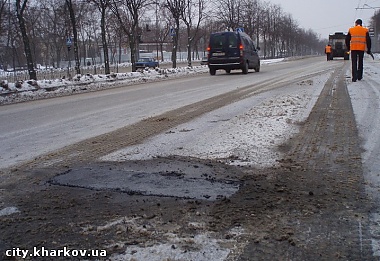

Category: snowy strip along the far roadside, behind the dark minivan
[0, 58, 284, 105]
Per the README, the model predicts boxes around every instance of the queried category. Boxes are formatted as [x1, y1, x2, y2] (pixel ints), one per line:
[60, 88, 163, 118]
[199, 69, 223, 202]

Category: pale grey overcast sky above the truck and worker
[268, 0, 380, 39]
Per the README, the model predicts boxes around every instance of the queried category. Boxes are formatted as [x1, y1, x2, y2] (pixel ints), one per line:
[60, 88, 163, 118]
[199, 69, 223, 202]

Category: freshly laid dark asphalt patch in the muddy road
[49, 155, 240, 200]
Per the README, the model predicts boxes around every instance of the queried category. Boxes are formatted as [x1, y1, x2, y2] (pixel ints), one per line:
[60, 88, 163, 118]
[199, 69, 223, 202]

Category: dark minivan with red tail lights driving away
[207, 31, 260, 75]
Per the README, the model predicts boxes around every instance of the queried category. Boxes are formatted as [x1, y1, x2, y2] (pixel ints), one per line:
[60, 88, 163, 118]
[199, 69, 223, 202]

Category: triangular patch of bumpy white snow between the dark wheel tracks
[101, 75, 328, 167]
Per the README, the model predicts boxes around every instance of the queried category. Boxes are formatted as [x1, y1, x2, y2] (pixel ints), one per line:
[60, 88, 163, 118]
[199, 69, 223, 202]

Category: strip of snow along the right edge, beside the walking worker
[346, 54, 380, 257]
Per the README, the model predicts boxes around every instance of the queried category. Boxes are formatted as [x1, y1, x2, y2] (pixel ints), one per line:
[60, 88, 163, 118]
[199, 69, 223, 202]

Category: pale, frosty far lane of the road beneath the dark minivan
[0, 57, 338, 167]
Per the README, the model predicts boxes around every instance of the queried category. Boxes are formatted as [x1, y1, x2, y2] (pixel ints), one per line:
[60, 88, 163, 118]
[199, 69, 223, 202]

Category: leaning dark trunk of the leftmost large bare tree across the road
[16, 0, 37, 80]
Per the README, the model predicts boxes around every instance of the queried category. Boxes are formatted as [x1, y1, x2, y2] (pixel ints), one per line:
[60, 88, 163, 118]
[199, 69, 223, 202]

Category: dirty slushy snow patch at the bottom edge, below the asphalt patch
[88, 213, 249, 261]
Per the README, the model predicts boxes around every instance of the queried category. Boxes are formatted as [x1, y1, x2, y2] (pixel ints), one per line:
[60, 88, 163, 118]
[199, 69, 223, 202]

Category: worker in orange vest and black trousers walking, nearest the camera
[346, 19, 371, 82]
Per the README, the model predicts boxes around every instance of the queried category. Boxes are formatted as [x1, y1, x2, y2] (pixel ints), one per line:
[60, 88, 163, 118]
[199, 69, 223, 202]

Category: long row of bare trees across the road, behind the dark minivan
[0, 0, 324, 79]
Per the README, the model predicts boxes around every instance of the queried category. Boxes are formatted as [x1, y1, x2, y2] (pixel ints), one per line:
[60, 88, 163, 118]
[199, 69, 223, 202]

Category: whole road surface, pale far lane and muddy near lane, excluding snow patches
[0, 55, 379, 260]
